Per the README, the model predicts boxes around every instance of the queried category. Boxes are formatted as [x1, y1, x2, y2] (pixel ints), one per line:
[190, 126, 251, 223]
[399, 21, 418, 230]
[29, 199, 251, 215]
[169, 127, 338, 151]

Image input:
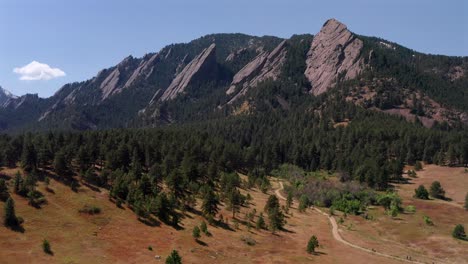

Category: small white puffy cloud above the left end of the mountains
[13, 61, 65, 81]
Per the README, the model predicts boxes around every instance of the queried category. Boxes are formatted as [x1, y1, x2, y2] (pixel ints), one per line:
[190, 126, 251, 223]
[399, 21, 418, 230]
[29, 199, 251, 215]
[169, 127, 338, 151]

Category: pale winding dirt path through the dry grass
[275, 181, 432, 264]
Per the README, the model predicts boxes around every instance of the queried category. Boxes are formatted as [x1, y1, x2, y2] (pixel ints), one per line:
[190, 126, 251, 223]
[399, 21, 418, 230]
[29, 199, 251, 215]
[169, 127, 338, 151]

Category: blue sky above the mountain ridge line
[0, 0, 468, 97]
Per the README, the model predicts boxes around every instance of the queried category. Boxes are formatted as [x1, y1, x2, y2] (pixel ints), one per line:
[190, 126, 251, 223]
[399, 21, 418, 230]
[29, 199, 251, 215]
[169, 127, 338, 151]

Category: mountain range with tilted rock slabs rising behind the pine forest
[0, 19, 468, 132]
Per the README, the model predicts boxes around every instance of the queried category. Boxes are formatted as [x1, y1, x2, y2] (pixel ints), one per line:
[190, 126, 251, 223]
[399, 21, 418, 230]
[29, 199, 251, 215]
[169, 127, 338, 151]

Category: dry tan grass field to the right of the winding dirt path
[330, 165, 468, 263]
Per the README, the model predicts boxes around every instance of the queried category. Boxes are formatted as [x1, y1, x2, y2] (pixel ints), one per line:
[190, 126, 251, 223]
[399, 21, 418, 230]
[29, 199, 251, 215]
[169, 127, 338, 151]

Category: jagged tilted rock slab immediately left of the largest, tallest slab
[226, 40, 286, 104]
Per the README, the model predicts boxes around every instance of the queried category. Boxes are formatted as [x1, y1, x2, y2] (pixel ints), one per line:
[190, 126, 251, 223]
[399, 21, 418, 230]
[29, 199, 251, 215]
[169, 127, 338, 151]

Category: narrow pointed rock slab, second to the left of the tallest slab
[160, 44, 217, 101]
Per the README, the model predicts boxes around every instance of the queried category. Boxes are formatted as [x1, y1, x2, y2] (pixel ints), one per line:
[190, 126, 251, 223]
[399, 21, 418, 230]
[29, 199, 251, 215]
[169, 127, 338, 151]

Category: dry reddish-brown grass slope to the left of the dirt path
[0, 170, 402, 263]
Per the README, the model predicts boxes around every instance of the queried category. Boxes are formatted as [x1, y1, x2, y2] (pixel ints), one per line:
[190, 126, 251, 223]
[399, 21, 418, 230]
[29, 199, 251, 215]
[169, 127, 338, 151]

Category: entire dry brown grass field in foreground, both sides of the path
[0, 167, 468, 263]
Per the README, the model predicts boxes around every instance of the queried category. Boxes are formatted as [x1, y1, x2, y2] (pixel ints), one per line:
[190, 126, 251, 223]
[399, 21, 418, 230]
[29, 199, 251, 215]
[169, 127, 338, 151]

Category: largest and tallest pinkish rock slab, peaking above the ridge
[305, 19, 363, 95]
